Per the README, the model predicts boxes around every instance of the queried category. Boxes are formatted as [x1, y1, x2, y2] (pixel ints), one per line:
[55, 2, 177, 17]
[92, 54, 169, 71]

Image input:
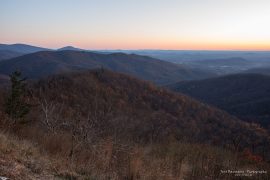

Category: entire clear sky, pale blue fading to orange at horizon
[0, 0, 270, 50]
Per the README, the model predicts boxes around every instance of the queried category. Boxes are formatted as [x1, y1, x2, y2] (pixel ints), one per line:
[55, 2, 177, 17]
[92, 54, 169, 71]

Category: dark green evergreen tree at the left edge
[5, 71, 30, 123]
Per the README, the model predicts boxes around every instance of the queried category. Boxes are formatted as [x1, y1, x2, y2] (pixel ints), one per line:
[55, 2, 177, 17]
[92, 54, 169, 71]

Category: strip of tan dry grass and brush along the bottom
[0, 129, 268, 180]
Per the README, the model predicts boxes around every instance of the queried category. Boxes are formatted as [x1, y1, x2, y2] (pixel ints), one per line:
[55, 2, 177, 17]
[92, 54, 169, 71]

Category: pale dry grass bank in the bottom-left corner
[0, 133, 58, 179]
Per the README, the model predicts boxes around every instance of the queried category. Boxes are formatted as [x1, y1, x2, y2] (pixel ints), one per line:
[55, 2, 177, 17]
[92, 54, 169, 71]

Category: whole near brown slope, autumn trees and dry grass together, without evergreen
[0, 70, 269, 179]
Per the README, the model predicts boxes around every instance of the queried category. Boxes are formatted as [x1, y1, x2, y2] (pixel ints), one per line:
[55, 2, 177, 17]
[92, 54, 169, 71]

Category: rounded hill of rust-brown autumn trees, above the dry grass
[20, 70, 267, 151]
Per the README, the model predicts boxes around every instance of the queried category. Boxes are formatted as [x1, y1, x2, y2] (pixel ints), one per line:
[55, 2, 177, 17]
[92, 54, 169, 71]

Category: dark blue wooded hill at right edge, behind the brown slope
[168, 74, 270, 127]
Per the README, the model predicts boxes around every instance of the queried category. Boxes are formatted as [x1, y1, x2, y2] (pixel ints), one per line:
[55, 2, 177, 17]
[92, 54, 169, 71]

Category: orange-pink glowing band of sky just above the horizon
[2, 38, 270, 51]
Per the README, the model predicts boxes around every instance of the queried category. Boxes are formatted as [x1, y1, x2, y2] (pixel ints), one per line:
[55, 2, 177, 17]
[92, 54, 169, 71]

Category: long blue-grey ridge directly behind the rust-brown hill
[0, 51, 214, 85]
